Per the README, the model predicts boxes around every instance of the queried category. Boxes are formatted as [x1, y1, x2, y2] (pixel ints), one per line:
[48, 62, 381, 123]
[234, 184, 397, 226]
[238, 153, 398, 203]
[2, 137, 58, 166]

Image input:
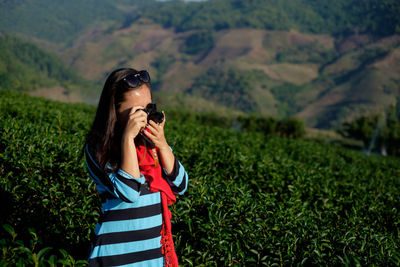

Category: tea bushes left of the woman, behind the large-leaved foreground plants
[0, 91, 99, 262]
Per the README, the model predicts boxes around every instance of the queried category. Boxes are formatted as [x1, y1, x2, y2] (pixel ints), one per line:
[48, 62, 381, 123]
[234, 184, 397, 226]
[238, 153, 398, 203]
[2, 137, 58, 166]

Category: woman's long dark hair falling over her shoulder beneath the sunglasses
[84, 68, 151, 172]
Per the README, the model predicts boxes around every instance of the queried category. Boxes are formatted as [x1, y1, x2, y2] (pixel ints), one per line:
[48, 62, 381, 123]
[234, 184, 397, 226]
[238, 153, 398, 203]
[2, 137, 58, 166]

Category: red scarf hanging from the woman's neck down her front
[136, 141, 178, 267]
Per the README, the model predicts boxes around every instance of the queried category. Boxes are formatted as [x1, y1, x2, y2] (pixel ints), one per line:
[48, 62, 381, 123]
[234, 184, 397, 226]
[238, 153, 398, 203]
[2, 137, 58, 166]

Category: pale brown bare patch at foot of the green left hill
[28, 86, 84, 103]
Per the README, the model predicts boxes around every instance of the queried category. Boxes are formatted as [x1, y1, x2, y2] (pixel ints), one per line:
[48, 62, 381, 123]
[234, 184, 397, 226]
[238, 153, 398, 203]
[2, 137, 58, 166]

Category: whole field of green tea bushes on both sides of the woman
[0, 91, 400, 266]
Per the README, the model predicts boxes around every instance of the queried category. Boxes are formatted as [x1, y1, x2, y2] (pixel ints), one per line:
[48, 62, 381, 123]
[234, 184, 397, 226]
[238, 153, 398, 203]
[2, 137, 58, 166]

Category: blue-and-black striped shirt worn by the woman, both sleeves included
[85, 145, 188, 266]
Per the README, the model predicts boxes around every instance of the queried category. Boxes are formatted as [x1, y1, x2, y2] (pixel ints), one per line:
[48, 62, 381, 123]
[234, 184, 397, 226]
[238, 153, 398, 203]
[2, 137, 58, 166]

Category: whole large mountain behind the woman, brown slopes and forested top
[0, 0, 400, 129]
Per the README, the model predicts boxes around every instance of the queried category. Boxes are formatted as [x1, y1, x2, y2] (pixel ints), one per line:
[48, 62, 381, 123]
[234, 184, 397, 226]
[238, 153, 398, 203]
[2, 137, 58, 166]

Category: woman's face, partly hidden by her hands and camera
[117, 84, 151, 127]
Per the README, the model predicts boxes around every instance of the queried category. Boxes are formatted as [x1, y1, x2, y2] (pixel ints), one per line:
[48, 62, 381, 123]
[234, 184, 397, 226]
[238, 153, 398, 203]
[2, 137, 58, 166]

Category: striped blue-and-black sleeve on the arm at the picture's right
[162, 147, 188, 195]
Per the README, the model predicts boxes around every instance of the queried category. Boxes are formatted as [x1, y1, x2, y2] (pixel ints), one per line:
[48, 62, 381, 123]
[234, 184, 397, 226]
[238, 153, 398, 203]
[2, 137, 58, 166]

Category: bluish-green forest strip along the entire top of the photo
[0, 0, 400, 43]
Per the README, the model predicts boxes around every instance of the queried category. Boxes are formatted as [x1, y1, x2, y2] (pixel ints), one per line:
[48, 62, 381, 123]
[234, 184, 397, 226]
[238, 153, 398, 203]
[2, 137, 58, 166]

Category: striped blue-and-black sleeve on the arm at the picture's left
[85, 145, 146, 203]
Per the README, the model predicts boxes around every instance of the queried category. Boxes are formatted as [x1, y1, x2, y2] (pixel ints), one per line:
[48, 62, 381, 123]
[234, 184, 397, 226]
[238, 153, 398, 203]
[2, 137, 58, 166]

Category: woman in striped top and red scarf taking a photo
[85, 68, 188, 266]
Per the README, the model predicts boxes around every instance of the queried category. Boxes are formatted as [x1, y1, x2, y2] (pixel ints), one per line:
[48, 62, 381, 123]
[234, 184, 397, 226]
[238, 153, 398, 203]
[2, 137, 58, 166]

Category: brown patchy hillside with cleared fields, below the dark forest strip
[60, 21, 400, 128]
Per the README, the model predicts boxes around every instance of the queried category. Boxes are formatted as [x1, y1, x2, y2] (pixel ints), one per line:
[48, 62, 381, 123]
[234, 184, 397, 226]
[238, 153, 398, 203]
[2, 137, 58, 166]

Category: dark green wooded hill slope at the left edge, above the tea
[0, 35, 94, 102]
